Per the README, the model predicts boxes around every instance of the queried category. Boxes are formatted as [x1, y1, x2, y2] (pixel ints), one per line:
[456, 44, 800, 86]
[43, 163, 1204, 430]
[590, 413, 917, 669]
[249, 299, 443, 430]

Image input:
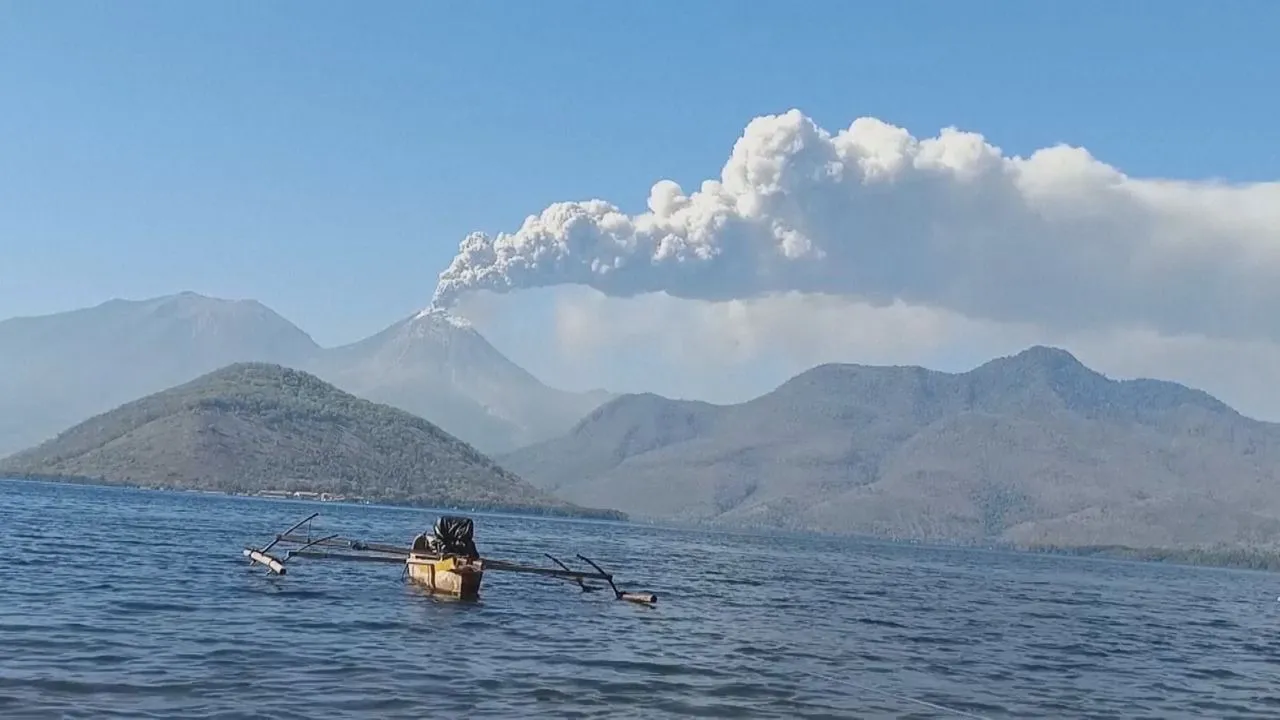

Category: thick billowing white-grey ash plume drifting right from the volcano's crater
[433, 110, 1280, 340]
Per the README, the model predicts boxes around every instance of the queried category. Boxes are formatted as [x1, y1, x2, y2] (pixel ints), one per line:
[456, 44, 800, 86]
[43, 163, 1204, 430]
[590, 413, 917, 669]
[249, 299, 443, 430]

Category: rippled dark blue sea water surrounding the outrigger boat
[0, 480, 1280, 719]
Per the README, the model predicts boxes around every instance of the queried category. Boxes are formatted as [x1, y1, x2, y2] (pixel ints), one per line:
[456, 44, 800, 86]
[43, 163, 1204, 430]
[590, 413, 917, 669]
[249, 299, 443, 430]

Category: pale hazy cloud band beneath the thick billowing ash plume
[465, 288, 1280, 420]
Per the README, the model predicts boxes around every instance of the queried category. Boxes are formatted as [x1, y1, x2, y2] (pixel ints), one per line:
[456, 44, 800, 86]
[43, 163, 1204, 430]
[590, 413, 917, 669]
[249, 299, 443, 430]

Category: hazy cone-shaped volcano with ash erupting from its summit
[308, 310, 612, 452]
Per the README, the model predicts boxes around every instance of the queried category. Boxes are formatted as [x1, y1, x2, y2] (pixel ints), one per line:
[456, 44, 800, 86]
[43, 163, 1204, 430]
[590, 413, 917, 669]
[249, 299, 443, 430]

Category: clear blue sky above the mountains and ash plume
[0, 0, 1280, 404]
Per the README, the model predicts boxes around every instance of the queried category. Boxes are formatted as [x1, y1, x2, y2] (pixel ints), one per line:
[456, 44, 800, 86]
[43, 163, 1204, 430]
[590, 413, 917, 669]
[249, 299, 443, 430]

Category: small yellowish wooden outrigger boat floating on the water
[244, 512, 658, 605]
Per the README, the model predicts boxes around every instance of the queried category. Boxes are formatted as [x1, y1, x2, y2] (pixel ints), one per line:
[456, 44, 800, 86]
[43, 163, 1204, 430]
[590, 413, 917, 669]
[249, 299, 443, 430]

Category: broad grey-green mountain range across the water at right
[498, 347, 1280, 547]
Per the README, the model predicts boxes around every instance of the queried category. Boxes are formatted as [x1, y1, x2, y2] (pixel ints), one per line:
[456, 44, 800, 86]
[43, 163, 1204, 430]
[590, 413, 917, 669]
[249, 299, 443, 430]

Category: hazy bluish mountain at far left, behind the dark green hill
[0, 292, 320, 456]
